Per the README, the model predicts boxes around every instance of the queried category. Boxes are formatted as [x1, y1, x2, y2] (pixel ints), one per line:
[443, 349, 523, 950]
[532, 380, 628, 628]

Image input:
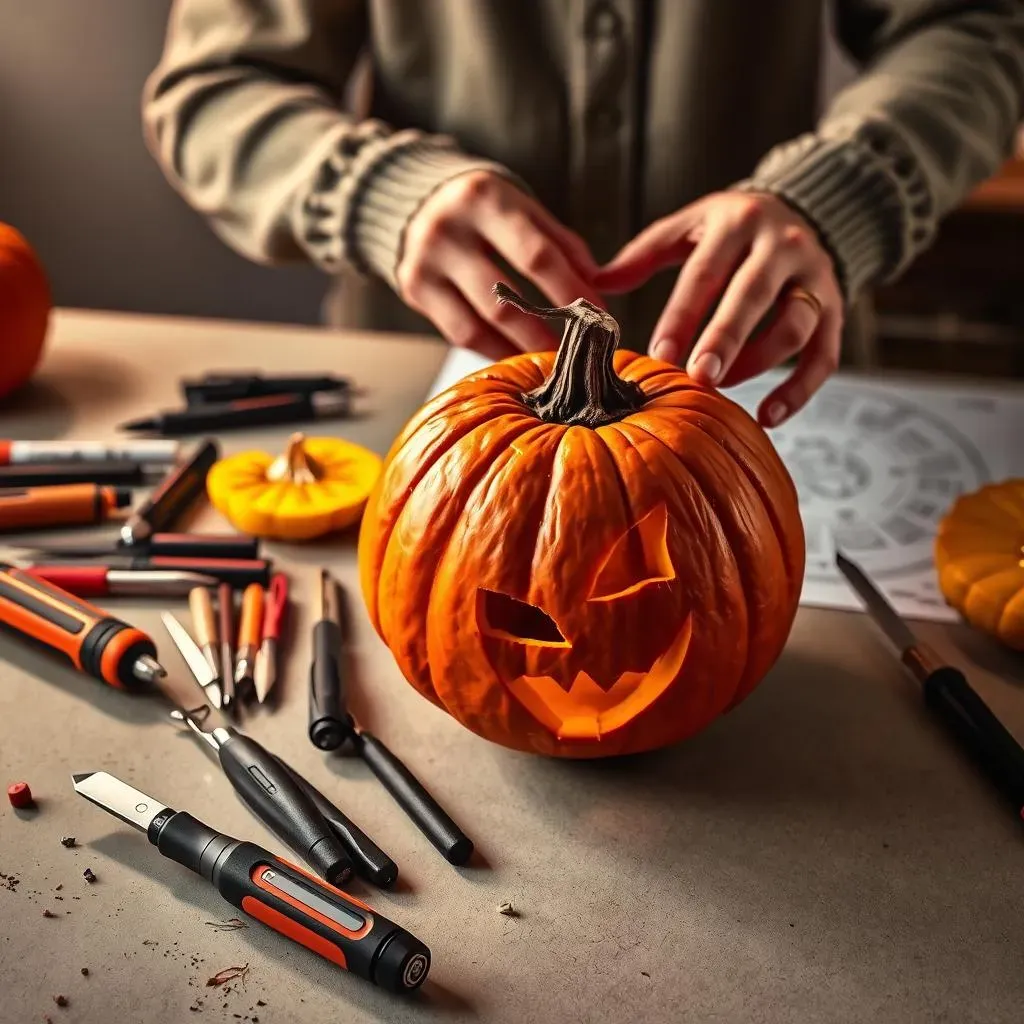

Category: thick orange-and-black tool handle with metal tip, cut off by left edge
[0, 562, 163, 690]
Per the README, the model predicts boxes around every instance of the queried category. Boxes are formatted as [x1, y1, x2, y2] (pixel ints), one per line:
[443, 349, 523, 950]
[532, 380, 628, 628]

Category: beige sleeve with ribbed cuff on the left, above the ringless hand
[142, 0, 516, 287]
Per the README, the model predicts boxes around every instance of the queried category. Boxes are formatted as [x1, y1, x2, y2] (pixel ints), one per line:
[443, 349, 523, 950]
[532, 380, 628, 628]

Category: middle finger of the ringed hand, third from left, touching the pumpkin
[686, 240, 798, 386]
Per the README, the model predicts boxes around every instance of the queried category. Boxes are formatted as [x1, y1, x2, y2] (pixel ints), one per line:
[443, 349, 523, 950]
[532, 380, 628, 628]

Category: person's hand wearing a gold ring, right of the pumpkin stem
[594, 190, 844, 427]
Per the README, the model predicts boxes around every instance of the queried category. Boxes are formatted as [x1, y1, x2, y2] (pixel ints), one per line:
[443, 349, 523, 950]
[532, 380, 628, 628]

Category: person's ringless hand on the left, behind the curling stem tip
[396, 172, 604, 359]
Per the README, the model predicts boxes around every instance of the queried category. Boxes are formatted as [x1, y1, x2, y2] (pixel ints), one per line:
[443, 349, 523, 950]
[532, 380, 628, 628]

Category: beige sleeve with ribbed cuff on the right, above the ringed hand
[741, 0, 1024, 298]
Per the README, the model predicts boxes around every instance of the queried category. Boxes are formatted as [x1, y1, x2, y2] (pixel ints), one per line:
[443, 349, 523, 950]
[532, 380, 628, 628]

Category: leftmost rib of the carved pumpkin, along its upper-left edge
[358, 392, 527, 634]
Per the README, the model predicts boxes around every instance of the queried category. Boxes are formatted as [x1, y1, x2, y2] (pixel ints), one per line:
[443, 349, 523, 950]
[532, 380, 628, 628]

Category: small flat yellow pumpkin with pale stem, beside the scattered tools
[206, 434, 382, 541]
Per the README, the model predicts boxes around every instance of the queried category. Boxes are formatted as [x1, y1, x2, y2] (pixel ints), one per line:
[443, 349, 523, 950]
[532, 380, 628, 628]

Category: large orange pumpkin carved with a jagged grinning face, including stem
[359, 286, 805, 758]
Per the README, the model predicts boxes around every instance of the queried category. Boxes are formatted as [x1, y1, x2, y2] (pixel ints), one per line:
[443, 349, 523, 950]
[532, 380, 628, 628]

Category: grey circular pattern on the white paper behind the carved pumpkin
[729, 378, 990, 581]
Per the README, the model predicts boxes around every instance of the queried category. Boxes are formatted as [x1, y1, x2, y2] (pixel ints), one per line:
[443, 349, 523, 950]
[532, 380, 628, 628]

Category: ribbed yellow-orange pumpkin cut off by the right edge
[935, 479, 1024, 650]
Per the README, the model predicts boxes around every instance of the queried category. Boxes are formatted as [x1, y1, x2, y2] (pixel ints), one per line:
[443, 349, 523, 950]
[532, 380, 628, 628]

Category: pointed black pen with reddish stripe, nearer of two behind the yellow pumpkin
[121, 390, 351, 436]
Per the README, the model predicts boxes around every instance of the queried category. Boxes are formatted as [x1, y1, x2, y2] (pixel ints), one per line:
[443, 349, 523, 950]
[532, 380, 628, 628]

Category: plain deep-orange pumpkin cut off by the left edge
[0, 224, 51, 398]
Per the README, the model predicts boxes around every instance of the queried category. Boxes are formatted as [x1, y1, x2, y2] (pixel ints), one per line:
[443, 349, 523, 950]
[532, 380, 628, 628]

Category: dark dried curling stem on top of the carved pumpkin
[494, 284, 644, 427]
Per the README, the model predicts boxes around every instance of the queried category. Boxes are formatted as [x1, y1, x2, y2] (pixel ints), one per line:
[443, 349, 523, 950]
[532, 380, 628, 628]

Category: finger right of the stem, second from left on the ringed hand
[650, 222, 748, 362]
